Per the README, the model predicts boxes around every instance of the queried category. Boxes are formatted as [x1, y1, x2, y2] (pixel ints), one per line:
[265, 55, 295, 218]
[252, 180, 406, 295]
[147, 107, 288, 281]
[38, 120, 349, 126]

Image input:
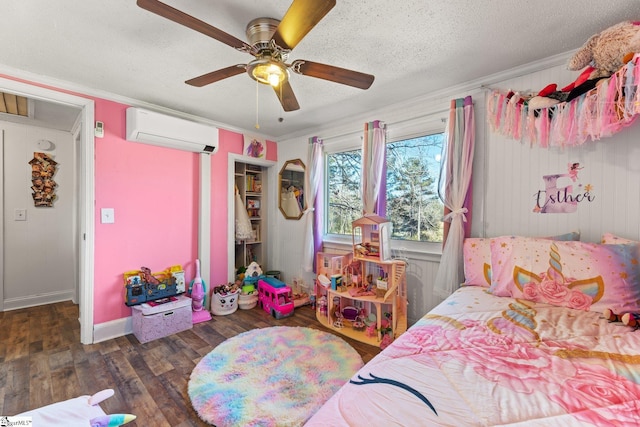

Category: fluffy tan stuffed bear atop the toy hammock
[567, 21, 640, 78]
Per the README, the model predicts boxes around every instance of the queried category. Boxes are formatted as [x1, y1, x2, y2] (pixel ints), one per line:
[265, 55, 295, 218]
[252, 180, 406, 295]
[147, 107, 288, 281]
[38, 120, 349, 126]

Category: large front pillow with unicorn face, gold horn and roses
[488, 237, 640, 313]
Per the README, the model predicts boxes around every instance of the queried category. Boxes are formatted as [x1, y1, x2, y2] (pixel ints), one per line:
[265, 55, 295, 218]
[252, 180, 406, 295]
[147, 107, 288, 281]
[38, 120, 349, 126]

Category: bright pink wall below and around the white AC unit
[2, 75, 277, 324]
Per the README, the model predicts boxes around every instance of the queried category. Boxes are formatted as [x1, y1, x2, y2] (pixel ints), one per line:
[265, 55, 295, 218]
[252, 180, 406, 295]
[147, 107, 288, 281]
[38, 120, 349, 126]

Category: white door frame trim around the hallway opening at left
[0, 78, 95, 344]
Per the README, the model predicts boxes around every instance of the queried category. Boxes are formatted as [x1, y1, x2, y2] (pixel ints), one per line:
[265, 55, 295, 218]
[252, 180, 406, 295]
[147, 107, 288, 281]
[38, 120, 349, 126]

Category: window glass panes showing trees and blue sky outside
[326, 133, 444, 242]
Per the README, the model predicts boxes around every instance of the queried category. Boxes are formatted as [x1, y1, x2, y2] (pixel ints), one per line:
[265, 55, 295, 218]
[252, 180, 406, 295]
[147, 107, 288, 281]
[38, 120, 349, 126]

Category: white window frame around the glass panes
[323, 114, 446, 256]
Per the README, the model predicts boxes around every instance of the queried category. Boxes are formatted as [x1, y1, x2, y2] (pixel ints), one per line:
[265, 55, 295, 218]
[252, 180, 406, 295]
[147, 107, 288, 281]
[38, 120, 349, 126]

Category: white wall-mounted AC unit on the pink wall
[127, 107, 218, 154]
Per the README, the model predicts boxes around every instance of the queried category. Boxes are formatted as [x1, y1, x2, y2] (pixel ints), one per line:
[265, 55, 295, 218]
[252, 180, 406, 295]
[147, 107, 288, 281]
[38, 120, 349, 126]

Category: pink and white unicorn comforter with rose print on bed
[306, 287, 640, 427]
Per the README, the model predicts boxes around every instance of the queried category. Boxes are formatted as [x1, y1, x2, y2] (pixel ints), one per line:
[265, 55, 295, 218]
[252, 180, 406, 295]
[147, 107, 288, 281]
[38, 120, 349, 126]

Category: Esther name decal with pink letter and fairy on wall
[533, 163, 596, 213]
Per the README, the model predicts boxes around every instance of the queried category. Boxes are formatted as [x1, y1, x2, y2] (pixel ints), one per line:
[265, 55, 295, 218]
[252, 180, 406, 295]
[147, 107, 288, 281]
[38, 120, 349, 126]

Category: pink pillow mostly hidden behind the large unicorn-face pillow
[462, 231, 580, 287]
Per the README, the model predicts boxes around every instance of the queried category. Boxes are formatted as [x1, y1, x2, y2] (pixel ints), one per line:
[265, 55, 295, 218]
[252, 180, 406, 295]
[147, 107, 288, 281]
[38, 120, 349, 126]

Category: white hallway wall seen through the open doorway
[0, 122, 76, 309]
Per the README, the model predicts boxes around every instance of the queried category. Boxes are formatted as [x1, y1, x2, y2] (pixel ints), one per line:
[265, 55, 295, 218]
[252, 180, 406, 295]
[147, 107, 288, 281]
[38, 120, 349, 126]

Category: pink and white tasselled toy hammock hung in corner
[487, 54, 640, 148]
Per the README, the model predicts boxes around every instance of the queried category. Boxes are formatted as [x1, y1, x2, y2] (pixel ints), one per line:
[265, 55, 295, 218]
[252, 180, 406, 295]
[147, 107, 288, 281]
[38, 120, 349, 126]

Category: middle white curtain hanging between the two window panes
[361, 120, 387, 215]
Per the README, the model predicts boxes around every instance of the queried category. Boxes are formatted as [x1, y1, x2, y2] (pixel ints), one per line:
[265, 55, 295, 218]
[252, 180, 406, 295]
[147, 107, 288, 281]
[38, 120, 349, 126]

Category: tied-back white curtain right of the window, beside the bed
[434, 96, 475, 300]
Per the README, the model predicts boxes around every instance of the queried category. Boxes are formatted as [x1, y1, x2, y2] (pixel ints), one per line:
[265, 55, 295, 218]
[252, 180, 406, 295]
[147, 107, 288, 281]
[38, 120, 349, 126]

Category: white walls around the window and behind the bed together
[273, 54, 640, 323]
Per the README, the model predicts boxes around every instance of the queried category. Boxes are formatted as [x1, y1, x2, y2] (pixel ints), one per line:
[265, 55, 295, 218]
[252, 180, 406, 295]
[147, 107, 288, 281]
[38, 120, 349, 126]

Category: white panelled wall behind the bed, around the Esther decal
[473, 66, 640, 242]
